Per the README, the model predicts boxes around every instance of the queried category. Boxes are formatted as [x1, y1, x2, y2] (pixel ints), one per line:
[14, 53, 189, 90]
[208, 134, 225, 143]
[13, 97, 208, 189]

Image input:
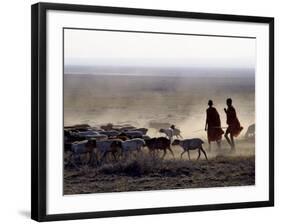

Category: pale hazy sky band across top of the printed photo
[64, 29, 256, 69]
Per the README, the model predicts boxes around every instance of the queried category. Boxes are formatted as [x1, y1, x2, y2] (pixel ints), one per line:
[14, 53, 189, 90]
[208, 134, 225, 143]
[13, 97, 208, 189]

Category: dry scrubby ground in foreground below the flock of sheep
[64, 145, 255, 195]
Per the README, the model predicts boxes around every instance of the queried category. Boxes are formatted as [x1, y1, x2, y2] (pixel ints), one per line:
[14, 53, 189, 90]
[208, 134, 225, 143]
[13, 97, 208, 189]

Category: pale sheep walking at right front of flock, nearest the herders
[172, 138, 208, 160]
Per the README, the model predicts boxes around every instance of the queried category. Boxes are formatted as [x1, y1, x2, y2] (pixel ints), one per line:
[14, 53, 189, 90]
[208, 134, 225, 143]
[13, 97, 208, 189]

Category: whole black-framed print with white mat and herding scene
[31, 3, 274, 221]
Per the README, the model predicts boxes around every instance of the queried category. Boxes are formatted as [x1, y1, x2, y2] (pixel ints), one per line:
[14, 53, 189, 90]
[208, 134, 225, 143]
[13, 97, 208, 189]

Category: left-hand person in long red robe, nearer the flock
[205, 100, 224, 151]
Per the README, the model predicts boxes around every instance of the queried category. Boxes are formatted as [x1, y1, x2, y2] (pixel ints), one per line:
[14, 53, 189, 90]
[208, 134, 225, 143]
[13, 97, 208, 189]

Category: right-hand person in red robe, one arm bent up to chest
[224, 98, 243, 150]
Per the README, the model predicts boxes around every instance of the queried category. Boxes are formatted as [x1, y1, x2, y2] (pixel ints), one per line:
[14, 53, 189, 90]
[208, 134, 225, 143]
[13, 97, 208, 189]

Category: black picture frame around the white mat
[31, 3, 274, 221]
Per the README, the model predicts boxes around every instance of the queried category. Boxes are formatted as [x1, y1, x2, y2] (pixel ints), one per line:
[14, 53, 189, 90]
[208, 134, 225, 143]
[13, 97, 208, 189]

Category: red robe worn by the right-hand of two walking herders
[226, 106, 243, 137]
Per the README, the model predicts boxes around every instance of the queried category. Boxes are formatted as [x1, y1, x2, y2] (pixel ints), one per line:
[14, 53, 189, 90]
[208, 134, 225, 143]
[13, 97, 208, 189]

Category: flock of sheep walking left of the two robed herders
[64, 124, 208, 166]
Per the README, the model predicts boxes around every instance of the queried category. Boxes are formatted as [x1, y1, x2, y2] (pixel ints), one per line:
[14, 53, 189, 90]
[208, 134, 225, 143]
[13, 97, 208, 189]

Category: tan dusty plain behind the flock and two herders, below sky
[64, 71, 255, 142]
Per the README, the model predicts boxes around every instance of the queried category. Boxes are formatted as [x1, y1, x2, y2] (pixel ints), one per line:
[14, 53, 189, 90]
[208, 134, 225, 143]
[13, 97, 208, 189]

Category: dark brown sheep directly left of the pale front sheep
[145, 137, 175, 159]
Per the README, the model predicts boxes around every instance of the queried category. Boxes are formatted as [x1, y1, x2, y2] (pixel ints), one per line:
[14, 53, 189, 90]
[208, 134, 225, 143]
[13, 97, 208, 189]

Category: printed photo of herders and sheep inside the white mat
[62, 27, 256, 195]
